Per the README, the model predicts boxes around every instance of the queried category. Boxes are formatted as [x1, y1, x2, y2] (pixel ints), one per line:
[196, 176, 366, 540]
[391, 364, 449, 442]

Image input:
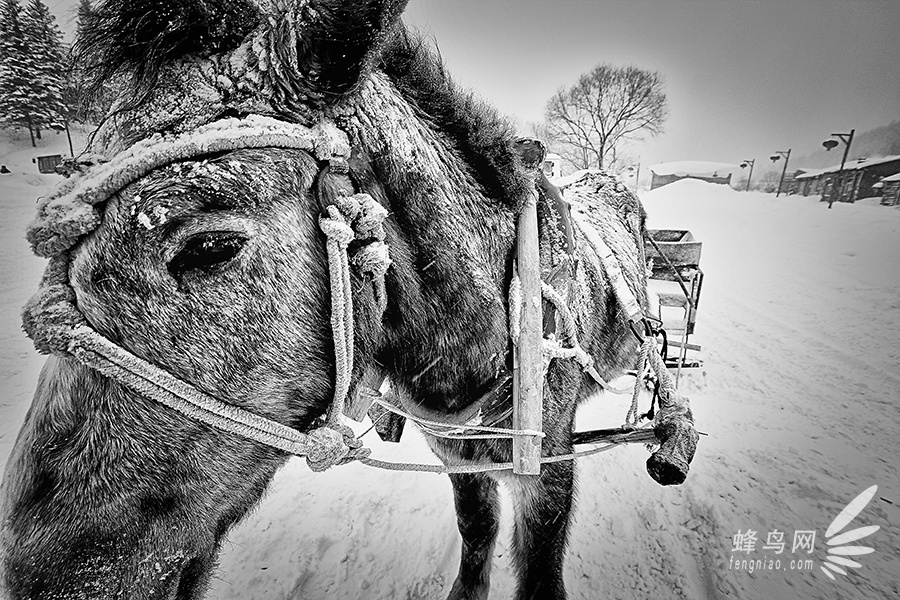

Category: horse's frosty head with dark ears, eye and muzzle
[0, 0, 424, 599]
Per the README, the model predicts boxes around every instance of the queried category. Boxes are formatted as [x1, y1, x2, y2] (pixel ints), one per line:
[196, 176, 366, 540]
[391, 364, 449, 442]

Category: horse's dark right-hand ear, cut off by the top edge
[291, 0, 408, 105]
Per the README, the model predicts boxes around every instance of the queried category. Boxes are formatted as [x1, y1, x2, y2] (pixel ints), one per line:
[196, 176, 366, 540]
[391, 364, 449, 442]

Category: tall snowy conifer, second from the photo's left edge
[22, 0, 68, 138]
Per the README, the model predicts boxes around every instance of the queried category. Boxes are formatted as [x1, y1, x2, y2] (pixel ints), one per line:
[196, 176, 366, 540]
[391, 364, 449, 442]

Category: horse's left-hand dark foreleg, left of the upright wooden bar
[448, 473, 500, 600]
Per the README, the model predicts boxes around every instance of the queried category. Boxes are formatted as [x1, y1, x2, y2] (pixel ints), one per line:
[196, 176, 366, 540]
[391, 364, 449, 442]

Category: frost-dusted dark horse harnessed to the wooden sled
[0, 0, 696, 600]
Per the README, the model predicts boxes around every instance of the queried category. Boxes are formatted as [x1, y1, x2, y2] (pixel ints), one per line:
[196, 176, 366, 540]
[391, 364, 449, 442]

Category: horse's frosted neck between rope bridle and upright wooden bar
[350, 75, 515, 410]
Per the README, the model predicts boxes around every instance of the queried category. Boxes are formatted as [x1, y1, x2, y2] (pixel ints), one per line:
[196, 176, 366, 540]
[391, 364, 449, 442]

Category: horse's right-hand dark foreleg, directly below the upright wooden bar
[510, 461, 575, 600]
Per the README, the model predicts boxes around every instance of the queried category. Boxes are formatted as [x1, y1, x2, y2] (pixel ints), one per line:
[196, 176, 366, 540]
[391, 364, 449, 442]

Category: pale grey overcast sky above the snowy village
[47, 0, 900, 168]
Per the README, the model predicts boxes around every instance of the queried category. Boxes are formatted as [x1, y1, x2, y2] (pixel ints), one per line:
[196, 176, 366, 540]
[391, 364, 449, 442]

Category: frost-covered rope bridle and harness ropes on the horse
[23, 116, 696, 483]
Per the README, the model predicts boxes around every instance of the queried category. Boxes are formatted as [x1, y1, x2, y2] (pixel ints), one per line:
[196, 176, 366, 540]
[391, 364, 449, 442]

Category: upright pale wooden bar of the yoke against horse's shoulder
[513, 138, 545, 475]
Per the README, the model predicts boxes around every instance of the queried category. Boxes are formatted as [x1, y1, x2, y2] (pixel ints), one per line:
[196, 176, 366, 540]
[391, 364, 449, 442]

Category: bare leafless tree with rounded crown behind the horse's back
[545, 64, 669, 169]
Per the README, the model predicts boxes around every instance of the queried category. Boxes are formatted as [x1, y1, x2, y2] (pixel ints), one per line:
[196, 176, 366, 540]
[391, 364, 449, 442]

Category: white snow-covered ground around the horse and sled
[0, 132, 900, 600]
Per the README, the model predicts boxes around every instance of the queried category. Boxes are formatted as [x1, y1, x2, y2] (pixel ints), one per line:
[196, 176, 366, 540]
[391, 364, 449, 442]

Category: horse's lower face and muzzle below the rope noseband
[0, 357, 285, 598]
